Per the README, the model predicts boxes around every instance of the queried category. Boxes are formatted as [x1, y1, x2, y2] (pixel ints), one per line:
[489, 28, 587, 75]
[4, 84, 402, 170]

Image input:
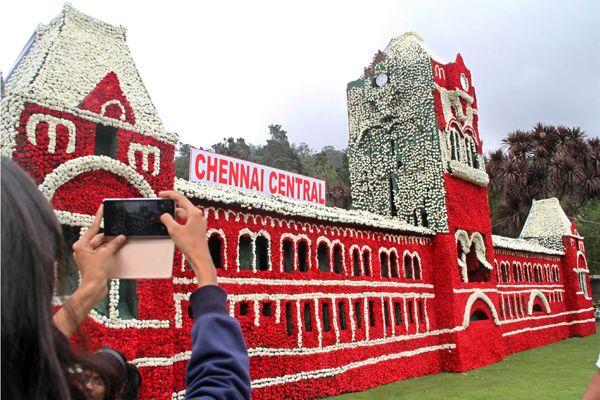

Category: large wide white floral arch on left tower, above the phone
[39, 156, 156, 200]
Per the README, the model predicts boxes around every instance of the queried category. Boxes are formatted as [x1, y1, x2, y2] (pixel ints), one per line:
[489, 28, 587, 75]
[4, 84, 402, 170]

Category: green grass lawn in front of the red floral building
[329, 324, 600, 400]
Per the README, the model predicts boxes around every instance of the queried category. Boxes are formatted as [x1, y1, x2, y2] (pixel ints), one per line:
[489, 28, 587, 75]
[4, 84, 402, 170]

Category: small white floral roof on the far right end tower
[519, 197, 573, 238]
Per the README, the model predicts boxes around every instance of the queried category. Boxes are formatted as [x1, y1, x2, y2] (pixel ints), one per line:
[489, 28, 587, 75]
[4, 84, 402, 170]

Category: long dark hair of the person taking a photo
[0, 157, 121, 400]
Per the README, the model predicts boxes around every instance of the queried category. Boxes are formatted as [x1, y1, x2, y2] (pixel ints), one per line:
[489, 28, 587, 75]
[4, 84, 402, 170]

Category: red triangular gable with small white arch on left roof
[78, 71, 135, 125]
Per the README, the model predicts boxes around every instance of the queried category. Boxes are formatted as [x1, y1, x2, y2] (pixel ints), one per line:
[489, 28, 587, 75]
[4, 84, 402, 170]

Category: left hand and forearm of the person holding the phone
[53, 206, 126, 337]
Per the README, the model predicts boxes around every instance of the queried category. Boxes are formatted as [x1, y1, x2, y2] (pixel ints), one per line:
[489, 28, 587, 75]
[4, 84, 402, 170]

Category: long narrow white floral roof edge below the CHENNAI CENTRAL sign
[175, 178, 434, 235]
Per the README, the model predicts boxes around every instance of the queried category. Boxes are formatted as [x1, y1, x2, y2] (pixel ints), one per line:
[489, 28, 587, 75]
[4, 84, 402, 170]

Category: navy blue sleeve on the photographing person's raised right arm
[185, 285, 250, 400]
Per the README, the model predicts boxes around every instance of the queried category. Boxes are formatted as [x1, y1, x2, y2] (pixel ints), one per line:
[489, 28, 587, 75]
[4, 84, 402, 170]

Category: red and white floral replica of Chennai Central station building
[0, 5, 596, 399]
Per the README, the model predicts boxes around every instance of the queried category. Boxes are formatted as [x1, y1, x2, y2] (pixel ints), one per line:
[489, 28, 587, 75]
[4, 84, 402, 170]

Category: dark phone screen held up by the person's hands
[104, 199, 175, 236]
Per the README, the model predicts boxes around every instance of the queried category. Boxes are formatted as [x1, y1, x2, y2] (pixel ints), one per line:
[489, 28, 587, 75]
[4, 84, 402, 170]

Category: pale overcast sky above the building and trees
[0, 0, 600, 150]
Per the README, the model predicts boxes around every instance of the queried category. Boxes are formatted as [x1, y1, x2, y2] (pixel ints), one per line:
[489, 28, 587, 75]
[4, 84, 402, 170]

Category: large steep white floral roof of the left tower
[3, 4, 176, 142]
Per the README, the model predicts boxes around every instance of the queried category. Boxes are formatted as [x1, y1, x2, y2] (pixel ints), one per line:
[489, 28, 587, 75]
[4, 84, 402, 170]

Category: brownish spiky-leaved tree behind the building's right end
[486, 123, 600, 236]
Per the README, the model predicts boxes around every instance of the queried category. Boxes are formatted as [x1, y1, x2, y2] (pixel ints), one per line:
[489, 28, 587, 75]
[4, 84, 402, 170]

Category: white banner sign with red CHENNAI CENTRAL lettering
[190, 149, 325, 204]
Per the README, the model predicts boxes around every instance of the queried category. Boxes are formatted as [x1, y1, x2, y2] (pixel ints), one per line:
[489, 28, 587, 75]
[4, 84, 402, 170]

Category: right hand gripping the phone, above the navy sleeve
[159, 191, 217, 287]
